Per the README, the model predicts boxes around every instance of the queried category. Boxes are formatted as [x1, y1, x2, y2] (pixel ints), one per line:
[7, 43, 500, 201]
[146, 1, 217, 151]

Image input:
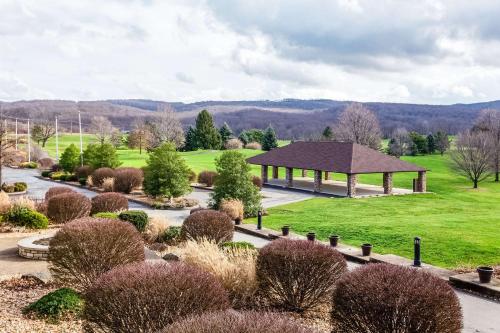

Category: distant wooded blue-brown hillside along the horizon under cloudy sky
[0, 99, 500, 139]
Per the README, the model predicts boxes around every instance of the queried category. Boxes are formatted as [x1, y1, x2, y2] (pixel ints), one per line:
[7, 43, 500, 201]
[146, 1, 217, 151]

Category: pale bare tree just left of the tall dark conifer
[147, 106, 184, 149]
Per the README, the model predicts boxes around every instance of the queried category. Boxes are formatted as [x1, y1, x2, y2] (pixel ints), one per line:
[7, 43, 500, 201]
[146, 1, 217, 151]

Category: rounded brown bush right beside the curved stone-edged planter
[48, 217, 145, 290]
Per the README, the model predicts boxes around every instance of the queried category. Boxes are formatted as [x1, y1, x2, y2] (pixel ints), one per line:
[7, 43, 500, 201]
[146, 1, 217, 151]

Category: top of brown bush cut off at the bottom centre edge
[162, 310, 318, 333]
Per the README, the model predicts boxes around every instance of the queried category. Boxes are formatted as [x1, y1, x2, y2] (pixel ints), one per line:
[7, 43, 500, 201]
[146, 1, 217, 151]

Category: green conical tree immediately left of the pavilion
[210, 150, 262, 216]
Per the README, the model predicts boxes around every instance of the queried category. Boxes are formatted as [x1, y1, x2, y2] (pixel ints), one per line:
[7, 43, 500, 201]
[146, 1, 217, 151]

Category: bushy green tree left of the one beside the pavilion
[143, 142, 192, 199]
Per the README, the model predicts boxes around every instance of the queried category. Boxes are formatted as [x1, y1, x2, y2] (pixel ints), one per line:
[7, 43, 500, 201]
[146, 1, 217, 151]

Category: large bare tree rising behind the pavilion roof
[334, 103, 382, 149]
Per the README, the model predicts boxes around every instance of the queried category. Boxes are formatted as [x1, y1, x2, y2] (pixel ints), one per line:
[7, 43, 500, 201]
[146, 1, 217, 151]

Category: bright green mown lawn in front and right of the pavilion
[247, 155, 500, 268]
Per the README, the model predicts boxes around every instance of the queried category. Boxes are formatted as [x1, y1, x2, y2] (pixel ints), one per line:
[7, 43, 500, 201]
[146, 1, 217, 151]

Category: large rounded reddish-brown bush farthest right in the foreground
[332, 264, 462, 333]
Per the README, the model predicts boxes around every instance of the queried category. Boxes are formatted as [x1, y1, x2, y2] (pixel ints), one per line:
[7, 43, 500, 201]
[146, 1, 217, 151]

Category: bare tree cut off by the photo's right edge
[474, 109, 500, 182]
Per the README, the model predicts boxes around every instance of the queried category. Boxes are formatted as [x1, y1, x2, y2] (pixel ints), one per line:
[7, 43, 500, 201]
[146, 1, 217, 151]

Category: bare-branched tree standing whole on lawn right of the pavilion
[451, 131, 491, 188]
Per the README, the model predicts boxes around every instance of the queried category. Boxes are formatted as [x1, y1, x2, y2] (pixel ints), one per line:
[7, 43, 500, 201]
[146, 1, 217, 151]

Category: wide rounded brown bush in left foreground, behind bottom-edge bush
[84, 263, 229, 333]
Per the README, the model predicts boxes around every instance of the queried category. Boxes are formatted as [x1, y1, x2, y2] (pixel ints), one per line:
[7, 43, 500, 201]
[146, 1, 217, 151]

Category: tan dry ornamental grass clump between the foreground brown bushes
[172, 240, 257, 307]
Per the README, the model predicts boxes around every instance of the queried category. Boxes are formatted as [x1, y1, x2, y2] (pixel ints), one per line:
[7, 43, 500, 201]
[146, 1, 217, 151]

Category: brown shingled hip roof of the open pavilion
[247, 141, 426, 174]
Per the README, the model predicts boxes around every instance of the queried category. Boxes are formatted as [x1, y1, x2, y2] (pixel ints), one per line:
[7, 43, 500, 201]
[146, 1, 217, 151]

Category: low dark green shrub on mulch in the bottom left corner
[23, 288, 84, 321]
